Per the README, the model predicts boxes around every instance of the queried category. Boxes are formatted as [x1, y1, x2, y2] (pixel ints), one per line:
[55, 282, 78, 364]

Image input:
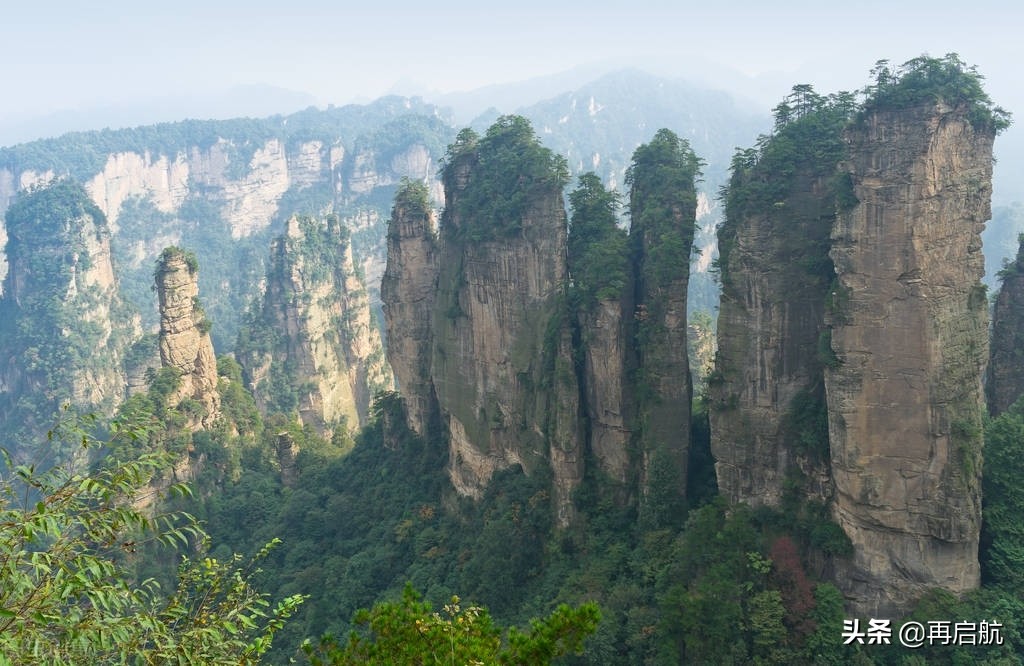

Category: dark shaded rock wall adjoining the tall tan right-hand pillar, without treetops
[709, 173, 836, 506]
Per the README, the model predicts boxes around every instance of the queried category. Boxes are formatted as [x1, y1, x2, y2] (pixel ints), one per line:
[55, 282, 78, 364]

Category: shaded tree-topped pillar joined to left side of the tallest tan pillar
[709, 92, 849, 506]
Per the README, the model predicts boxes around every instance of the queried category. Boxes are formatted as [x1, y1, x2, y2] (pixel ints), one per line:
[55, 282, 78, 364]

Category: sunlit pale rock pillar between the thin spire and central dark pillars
[238, 215, 392, 432]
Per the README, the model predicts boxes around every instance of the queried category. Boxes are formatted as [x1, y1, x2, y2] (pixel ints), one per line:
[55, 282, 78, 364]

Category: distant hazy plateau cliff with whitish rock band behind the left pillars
[0, 103, 451, 350]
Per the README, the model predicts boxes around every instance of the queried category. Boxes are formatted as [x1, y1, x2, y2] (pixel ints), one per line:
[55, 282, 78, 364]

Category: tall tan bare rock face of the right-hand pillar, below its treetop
[825, 102, 993, 617]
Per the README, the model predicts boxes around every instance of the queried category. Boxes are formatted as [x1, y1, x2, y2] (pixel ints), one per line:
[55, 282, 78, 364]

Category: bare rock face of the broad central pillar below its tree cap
[431, 142, 582, 515]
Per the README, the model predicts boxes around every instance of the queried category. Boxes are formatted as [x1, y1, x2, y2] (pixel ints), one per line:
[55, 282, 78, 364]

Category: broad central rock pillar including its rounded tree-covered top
[432, 119, 580, 506]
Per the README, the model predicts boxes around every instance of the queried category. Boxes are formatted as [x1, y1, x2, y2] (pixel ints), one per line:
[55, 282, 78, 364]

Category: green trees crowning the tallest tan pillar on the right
[858, 53, 1011, 134]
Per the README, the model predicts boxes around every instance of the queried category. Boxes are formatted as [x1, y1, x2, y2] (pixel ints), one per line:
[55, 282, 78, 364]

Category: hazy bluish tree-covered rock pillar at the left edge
[0, 180, 141, 446]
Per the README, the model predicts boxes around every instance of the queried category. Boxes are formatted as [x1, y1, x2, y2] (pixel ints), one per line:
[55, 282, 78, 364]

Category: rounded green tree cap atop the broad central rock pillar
[441, 116, 568, 241]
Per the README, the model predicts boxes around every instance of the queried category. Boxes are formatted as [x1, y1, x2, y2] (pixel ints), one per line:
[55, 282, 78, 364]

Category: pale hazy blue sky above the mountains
[0, 0, 1024, 144]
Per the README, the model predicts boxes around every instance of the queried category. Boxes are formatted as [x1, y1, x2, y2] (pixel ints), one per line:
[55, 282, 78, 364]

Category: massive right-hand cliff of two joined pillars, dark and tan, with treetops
[712, 66, 1000, 617]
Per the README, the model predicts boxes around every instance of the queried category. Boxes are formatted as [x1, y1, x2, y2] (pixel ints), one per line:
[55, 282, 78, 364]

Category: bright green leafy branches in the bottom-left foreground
[0, 411, 302, 664]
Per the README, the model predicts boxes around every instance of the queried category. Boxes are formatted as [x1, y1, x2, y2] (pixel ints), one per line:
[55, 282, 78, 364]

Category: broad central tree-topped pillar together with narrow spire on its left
[381, 118, 583, 525]
